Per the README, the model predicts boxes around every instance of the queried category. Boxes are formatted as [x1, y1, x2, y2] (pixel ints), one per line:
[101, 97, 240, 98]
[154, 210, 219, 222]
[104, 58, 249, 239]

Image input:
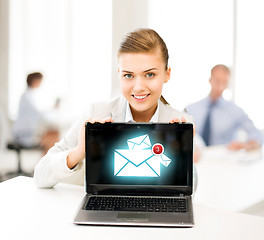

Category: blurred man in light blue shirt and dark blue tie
[185, 64, 263, 150]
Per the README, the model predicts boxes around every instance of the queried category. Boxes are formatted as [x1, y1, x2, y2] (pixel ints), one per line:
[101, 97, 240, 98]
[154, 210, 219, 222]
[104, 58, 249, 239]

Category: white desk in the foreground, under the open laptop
[0, 177, 264, 240]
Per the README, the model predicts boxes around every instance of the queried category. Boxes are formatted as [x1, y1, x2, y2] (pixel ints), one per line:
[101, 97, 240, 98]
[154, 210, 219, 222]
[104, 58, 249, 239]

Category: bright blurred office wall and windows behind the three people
[0, 0, 264, 214]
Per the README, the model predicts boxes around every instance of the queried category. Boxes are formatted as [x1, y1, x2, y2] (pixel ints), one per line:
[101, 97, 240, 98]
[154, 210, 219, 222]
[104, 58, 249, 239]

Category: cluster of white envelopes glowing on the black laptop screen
[114, 134, 171, 177]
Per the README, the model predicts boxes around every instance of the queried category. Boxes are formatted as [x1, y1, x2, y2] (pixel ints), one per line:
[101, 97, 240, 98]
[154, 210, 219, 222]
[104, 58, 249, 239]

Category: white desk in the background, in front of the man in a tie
[194, 146, 264, 212]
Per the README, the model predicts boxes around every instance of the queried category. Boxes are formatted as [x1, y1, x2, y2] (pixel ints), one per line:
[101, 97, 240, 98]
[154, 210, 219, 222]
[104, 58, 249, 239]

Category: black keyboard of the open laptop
[84, 196, 186, 212]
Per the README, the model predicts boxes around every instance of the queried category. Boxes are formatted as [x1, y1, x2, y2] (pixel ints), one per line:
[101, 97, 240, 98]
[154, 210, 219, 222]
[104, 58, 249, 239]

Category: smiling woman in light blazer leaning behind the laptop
[34, 29, 192, 188]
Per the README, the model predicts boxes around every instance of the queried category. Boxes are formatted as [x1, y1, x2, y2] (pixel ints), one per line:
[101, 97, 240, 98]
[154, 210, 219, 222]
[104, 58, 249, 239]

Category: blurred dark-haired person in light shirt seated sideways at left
[13, 72, 59, 154]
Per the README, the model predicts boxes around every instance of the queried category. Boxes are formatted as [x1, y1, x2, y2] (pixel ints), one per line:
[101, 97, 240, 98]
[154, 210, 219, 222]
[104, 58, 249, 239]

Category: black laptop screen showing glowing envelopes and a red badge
[85, 123, 193, 194]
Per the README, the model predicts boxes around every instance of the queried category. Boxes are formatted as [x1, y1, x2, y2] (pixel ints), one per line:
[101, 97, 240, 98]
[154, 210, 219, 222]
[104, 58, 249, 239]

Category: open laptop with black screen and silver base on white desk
[74, 123, 194, 227]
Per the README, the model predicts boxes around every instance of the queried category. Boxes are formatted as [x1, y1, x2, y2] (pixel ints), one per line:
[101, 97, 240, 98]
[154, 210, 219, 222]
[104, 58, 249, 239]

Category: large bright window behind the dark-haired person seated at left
[9, 0, 112, 119]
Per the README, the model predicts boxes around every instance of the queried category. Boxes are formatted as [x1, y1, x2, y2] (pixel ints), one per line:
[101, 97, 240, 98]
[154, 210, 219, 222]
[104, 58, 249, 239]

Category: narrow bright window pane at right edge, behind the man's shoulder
[235, 0, 264, 129]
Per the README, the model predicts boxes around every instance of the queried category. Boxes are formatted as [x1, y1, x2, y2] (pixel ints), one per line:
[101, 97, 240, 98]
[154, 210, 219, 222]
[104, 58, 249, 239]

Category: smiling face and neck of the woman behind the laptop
[118, 50, 171, 122]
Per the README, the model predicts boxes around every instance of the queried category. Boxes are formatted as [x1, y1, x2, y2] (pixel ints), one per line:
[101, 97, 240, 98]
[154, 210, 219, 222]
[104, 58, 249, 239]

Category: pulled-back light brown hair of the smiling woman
[118, 28, 169, 104]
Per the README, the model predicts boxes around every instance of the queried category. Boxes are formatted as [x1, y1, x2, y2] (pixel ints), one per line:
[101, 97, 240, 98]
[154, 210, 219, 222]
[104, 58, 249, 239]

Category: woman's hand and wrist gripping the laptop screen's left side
[67, 117, 113, 169]
